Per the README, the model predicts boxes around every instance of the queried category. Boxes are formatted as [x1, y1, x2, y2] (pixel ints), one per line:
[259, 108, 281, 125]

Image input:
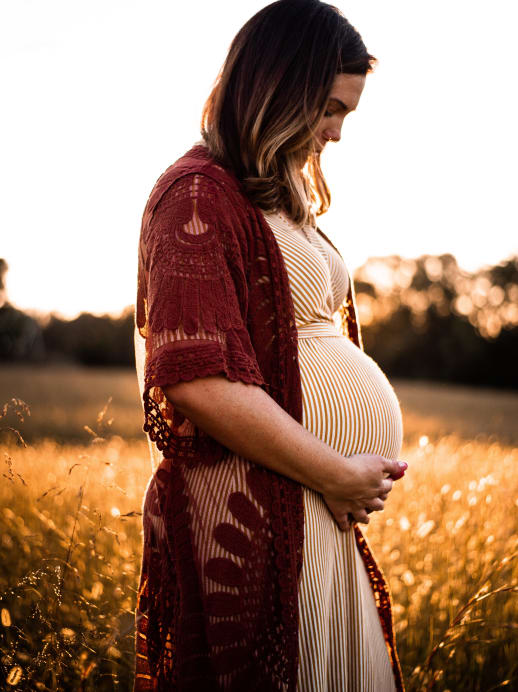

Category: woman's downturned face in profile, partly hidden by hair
[315, 74, 365, 153]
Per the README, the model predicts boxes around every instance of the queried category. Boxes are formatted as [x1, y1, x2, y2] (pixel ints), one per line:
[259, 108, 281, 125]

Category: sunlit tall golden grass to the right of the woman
[367, 436, 518, 692]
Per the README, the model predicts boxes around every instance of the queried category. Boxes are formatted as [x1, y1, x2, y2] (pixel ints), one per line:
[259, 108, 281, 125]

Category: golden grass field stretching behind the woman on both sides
[0, 367, 518, 692]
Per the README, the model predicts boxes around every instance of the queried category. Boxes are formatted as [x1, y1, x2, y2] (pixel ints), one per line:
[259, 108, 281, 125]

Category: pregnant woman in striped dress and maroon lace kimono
[135, 0, 406, 692]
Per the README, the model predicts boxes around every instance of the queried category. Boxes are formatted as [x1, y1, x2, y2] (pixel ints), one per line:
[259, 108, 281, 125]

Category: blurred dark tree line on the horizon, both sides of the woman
[0, 255, 518, 388]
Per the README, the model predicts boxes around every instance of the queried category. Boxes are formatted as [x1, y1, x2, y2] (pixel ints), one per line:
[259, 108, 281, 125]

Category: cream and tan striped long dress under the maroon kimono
[265, 209, 402, 692]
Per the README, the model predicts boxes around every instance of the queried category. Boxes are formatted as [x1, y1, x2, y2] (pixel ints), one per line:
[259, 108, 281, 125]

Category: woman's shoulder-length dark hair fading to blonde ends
[201, 0, 375, 223]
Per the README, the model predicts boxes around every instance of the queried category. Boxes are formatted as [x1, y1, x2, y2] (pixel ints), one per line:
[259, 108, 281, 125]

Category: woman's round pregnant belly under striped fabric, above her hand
[298, 336, 403, 459]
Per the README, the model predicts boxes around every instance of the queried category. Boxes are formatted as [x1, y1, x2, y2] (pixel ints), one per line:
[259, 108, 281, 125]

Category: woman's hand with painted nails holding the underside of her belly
[322, 454, 407, 531]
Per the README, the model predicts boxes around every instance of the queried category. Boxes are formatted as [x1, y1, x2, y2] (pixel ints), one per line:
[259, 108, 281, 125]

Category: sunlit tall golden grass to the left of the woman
[0, 398, 149, 690]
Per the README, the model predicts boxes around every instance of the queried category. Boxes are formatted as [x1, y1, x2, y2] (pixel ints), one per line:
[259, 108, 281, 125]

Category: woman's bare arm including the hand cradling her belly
[164, 375, 402, 528]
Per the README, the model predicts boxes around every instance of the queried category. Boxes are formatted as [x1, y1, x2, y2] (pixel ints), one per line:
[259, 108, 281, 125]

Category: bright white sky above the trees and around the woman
[0, 0, 518, 317]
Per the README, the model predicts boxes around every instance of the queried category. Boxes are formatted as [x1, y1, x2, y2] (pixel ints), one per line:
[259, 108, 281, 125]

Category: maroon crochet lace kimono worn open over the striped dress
[135, 145, 402, 692]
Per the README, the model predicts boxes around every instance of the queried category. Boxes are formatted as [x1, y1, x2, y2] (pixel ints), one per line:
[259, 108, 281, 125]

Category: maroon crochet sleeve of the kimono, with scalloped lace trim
[136, 174, 264, 457]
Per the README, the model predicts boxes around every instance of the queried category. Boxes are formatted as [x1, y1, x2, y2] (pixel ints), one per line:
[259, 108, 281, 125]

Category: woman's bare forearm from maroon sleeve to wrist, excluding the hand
[164, 375, 360, 494]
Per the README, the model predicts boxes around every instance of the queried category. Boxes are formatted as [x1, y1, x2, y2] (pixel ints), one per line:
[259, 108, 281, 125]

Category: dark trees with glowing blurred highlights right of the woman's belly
[355, 255, 518, 388]
